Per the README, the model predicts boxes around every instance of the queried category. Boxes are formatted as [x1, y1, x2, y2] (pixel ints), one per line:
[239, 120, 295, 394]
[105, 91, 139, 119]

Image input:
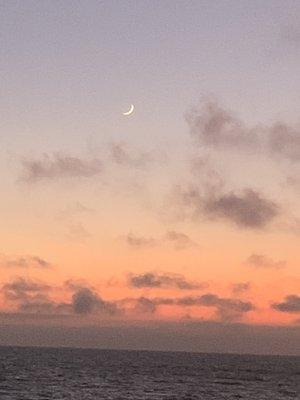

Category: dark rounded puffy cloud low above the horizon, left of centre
[72, 287, 117, 315]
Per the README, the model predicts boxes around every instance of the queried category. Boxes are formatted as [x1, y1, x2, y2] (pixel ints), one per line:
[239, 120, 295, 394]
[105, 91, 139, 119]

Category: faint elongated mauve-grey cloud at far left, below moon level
[21, 153, 102, 183]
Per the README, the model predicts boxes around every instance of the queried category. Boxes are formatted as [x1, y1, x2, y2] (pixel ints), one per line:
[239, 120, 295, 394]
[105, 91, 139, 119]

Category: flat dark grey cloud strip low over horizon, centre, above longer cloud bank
[128, 272, 204, 290]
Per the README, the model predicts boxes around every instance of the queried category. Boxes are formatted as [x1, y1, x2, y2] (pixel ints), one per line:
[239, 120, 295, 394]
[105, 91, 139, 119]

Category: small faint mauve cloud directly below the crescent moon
[110, 143, 152, 168]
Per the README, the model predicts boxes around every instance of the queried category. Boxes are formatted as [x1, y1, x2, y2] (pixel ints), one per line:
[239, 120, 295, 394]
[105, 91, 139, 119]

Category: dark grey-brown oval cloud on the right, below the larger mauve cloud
[179, 187, 280, 229]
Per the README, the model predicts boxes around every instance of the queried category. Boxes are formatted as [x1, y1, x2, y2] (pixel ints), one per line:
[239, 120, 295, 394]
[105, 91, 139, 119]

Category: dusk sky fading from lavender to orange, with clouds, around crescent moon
[0, 0, 300, 355]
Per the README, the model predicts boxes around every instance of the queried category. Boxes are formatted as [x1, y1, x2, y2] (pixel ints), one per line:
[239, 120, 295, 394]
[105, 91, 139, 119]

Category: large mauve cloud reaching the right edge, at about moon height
[186, 99, 300, 161]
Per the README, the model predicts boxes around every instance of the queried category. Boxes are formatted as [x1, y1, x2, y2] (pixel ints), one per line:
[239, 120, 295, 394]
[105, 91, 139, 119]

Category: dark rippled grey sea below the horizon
[0, 347, 300, 400]
